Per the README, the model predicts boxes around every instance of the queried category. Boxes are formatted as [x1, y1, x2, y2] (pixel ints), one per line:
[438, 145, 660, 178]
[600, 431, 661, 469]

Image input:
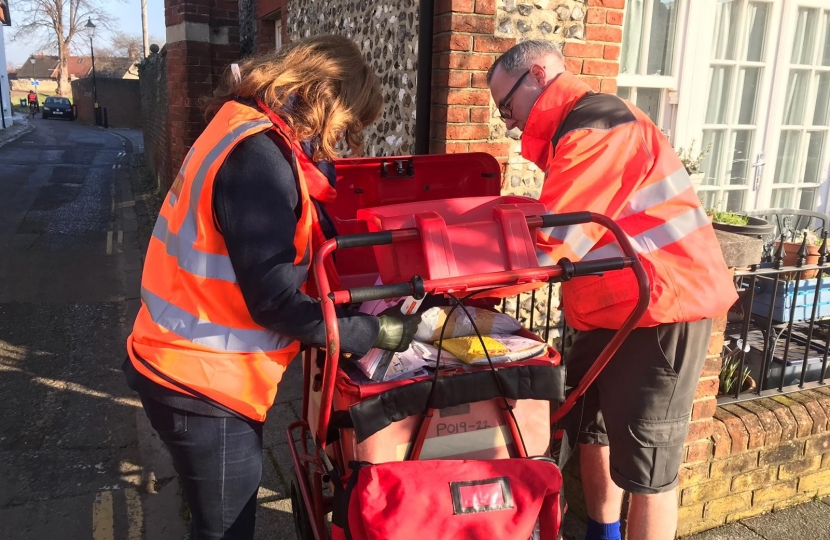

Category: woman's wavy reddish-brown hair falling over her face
[205, 35, 383, 160]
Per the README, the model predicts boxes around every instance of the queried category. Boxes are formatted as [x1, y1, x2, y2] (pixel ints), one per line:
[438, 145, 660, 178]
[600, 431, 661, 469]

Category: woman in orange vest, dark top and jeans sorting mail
[124, 36, 417, 540]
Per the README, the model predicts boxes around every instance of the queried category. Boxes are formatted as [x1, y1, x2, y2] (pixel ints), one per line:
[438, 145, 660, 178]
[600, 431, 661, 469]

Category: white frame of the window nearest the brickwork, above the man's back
[617, 0, 691, 141]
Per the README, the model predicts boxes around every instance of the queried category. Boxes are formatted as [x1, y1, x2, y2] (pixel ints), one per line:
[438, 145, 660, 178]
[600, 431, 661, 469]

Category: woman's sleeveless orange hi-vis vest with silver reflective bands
[127, 101, 322, 422]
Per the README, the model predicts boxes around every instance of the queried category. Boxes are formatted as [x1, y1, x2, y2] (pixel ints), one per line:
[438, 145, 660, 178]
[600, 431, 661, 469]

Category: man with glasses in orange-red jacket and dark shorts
[487, 41, 737, 540]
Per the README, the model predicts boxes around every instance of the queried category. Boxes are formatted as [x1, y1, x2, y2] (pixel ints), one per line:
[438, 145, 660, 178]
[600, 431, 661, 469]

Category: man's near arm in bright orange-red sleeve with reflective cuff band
[538, 122, 653, 265]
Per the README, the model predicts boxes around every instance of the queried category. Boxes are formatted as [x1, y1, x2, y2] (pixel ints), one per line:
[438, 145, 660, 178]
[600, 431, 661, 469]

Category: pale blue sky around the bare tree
[4, 0, 165, 66]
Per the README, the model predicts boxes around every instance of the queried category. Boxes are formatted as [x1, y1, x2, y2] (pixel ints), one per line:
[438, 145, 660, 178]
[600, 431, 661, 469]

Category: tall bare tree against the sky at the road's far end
[13, 0, 111, 96]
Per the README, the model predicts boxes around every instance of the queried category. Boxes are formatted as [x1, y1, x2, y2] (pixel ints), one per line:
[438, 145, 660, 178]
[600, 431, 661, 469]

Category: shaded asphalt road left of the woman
[0, 118, 153, 540]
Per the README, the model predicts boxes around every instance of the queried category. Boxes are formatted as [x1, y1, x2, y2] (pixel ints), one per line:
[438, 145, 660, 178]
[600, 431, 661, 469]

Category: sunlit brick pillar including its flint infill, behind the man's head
[430, 0, 625, 193]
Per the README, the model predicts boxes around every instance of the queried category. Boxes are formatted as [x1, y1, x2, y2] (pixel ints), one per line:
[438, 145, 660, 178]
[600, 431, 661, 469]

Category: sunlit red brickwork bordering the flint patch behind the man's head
[430, 0, 624, 167]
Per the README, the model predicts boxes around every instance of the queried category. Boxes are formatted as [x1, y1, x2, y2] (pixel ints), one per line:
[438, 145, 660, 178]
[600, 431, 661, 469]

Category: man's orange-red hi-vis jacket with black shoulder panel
[522, 72, 737, 330]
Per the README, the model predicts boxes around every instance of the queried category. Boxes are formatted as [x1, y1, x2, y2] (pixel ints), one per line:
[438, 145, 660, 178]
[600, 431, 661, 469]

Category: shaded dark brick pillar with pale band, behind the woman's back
[164, 0, 239, 187]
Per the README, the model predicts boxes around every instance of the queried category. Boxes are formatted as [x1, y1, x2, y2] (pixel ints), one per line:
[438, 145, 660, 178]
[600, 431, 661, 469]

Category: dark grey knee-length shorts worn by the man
[565, 320, 712, 495]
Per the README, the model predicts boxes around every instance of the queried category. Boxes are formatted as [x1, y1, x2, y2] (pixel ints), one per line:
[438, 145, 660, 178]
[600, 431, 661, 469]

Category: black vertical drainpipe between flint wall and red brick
[414, 0, 435, 154]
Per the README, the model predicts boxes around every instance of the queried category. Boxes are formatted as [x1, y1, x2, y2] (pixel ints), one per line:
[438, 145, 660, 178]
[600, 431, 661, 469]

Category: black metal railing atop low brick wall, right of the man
[718, 230, 830, 402]
